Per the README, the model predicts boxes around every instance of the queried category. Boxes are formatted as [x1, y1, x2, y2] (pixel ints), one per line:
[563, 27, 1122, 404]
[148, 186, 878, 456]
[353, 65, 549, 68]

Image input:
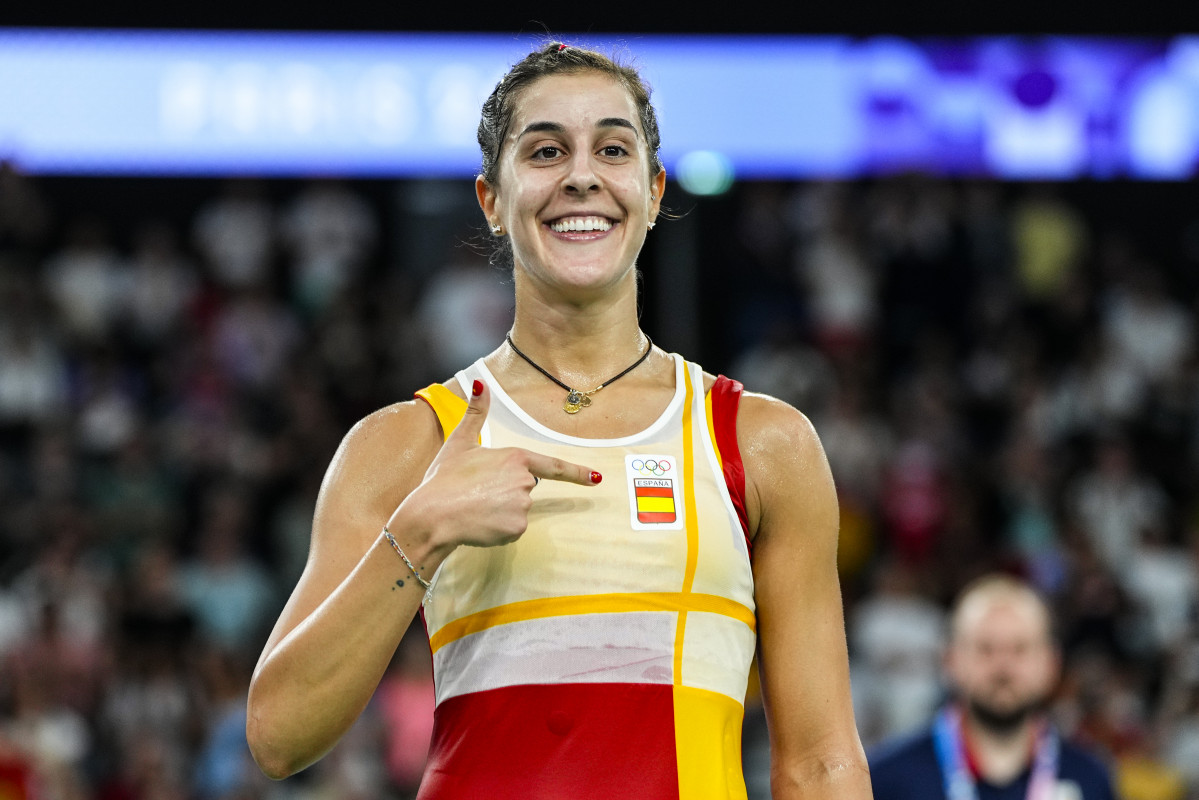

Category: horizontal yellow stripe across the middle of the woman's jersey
[429, 591, 758, 652]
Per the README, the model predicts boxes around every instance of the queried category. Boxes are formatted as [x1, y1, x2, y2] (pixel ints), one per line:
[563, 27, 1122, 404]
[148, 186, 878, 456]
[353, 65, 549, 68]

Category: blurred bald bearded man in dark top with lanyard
[870, 576, 1115, 800]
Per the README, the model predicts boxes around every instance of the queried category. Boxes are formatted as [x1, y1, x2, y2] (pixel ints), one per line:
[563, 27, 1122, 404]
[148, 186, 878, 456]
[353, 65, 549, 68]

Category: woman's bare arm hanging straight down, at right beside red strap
[737, 395, 866, 786]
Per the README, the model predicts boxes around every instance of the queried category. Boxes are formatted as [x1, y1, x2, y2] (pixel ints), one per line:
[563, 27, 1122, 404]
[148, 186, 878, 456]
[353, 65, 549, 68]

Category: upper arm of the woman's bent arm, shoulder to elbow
[255, 401, 441, 671]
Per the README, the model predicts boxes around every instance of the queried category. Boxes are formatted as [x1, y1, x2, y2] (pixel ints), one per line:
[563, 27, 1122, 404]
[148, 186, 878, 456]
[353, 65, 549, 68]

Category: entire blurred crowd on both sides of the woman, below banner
[0, 159, 1199, 800]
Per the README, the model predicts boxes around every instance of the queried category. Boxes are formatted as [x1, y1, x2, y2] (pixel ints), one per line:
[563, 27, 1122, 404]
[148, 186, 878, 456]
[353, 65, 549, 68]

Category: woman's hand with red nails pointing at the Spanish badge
[387, 380, 602, 554]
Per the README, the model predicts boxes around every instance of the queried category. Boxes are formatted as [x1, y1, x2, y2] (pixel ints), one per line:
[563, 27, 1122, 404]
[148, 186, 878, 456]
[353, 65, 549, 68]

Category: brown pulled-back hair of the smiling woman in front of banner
[478, 42, 662, 186]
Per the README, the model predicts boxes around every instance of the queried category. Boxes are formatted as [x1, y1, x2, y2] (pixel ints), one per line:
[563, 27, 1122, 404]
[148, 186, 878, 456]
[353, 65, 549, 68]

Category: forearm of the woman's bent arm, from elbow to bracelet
[246, 536, 444, 778]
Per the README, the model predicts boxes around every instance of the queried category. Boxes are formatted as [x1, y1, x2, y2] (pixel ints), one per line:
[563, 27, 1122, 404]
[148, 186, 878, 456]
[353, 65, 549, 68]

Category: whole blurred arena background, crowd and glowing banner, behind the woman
[0, 2, 1199, 800]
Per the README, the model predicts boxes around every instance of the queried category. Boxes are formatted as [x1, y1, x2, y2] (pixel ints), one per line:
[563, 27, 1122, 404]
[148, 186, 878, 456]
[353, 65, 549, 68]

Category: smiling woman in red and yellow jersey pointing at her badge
[247, 38, 870, 800]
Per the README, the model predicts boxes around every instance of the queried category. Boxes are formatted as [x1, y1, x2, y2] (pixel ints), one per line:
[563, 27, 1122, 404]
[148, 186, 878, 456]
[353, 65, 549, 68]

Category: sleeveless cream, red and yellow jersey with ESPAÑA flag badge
[417, 355, 757, 800]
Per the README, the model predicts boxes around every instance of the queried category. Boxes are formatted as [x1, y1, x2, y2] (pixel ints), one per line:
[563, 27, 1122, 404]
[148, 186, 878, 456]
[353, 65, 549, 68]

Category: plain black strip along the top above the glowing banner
[0, 0, 1179, 36]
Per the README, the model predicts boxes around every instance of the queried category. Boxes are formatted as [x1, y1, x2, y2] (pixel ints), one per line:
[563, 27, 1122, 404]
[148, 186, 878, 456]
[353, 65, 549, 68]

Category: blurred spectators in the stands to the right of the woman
[724, 178, 1199, 800]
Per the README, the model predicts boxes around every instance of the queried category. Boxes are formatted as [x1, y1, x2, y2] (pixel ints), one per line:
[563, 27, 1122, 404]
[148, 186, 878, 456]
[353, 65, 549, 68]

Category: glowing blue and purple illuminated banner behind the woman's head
[0, 29, 1199, 178]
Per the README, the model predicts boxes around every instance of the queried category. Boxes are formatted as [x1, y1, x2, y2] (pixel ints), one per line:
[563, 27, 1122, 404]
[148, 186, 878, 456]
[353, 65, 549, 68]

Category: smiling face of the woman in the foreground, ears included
[476, 72, 665, 295]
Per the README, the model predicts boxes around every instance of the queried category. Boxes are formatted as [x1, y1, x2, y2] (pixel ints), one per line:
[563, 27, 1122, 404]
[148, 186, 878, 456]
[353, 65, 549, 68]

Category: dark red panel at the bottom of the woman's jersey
[417, 684, 679, 800]
